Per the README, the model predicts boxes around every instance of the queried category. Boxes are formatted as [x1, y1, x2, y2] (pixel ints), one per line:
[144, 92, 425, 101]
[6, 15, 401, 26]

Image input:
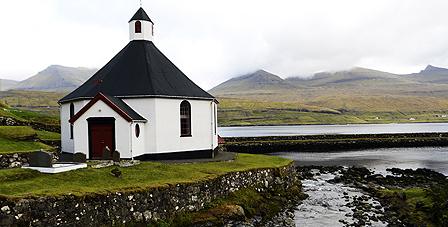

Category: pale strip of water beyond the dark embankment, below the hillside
[219, 123, 448, 137]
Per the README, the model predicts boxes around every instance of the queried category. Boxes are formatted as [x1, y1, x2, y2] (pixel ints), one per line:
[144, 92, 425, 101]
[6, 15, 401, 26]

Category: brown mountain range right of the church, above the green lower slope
[210, 66, 448, 112]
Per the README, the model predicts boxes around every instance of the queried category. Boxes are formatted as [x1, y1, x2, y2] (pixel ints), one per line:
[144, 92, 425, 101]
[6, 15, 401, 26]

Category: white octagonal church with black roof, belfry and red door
[59, 8, 218, 159]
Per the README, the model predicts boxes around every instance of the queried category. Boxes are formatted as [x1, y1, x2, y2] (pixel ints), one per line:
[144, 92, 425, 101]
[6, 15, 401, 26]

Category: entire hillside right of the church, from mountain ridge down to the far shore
[210, 66, 448, 125]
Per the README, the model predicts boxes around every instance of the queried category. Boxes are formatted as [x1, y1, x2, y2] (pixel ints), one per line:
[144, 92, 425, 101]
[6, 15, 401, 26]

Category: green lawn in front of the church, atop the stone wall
[0, 154, 291, 197]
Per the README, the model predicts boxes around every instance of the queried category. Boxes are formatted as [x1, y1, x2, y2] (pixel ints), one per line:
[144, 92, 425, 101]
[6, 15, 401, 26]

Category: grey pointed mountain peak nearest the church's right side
[210, 70, 295, 95]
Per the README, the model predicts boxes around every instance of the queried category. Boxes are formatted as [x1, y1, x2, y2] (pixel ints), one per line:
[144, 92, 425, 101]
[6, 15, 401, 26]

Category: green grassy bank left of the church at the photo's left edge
[0, 126, 60, 154]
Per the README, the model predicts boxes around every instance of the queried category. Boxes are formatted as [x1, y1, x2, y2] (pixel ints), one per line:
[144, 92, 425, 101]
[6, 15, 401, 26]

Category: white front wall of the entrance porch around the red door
[73, 100, 131, 158]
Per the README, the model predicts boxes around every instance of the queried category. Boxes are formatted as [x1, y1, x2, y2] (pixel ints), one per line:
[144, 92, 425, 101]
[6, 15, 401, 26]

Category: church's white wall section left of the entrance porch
[60, 100, 89, 153]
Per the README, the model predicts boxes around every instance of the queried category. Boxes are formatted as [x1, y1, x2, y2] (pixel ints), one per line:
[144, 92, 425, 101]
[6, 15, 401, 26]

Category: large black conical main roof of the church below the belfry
[59, 40, 215, 103]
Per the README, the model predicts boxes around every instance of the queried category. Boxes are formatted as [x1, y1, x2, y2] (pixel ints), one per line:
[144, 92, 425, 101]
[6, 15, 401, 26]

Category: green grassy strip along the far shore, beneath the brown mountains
[218, 98, 448, 126]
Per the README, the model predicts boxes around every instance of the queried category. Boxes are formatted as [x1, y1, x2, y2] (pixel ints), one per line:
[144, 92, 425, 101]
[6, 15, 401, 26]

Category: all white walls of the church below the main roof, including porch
[61, 98, 218, 158]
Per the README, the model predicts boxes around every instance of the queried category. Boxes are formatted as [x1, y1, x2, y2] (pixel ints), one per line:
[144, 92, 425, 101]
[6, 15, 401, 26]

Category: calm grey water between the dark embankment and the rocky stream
[273, 147, 448, 175]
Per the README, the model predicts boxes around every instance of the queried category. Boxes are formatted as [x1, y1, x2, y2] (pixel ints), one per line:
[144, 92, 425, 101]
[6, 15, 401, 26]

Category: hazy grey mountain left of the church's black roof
[12, 65, 97, 92]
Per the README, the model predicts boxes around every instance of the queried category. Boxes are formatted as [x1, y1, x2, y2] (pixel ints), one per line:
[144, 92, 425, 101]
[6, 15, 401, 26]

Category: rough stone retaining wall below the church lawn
[0, 164, 300, 226]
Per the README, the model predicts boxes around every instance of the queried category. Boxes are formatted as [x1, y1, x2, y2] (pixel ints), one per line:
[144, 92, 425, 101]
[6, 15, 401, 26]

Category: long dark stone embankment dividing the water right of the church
[224, 133, 448, 154]
